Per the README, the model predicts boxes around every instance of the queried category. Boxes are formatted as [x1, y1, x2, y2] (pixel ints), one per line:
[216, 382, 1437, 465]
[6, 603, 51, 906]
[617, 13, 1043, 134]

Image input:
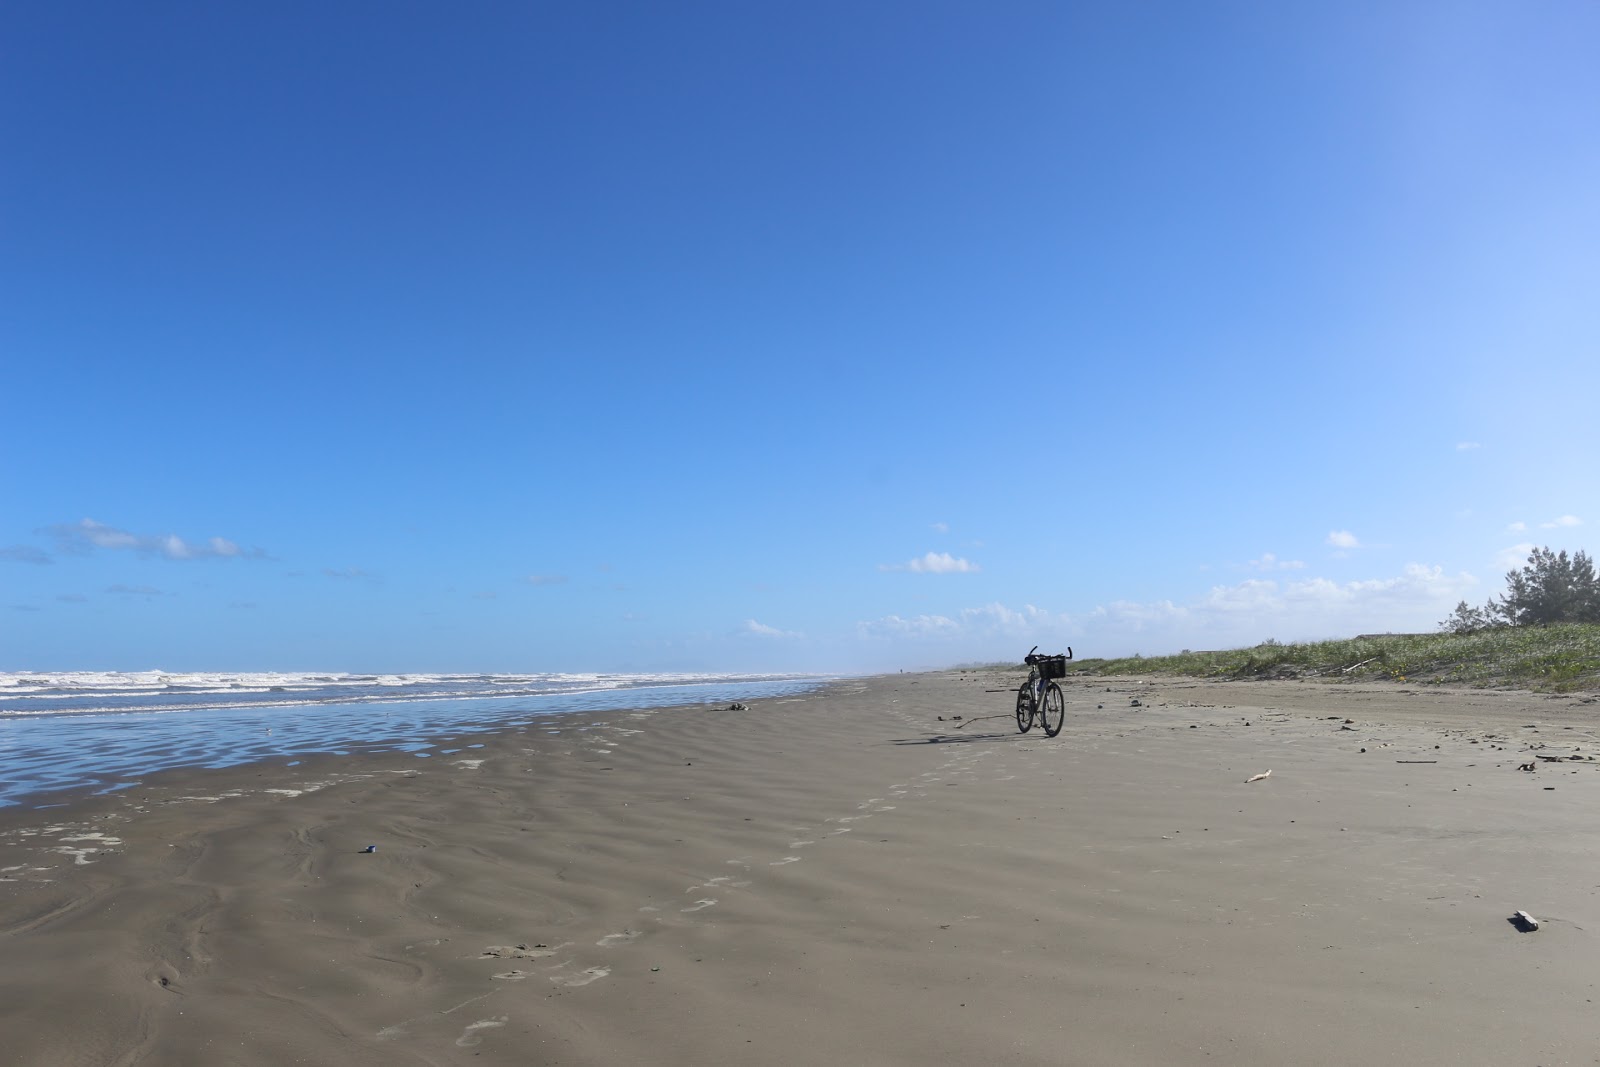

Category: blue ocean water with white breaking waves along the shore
[0, 670, 826, 806]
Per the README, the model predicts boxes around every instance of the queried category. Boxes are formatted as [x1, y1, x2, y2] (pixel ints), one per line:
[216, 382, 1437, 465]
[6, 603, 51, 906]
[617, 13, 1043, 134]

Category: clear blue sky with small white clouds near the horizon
[0, 3, 1600, 672]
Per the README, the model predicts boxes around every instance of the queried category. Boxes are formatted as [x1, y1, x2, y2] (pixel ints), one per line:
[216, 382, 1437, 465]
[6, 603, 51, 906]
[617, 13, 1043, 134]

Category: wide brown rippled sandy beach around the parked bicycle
[0, 672, 1600, 1067]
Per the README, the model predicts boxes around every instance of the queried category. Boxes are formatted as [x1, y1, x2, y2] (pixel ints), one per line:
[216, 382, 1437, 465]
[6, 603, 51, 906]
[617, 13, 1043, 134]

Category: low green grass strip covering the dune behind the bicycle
[1074, 622, 1600, 693]
